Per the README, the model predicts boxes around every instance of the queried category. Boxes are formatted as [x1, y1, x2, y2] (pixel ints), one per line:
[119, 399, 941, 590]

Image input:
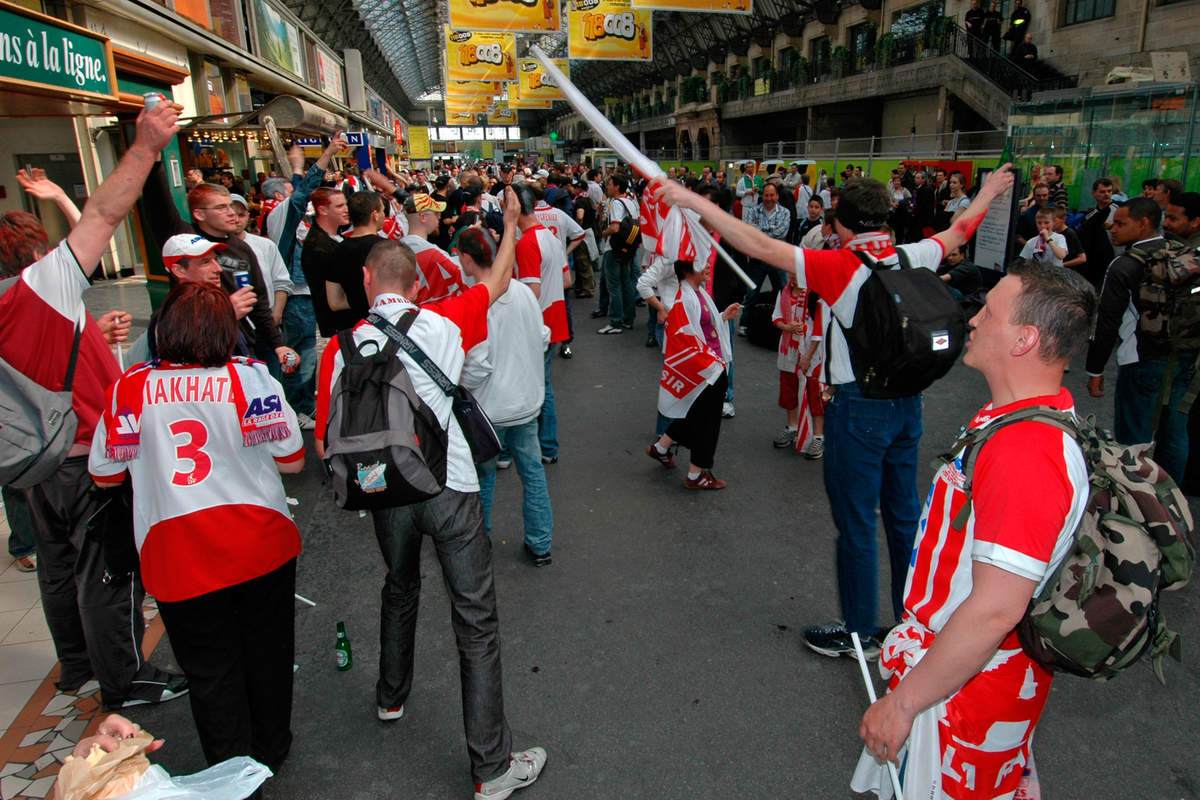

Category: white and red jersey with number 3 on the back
[88, 361, 304, 602]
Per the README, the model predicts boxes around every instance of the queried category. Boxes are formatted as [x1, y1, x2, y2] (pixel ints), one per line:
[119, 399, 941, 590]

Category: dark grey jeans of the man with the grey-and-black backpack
[371, 489, 512, 783]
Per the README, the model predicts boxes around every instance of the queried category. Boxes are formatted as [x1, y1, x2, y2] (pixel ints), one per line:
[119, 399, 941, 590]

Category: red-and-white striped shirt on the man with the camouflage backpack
[904, 389, 1088, 633]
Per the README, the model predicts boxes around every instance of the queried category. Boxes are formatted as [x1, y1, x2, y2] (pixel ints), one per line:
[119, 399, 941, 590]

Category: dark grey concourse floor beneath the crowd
[0, 279, 1200, 800]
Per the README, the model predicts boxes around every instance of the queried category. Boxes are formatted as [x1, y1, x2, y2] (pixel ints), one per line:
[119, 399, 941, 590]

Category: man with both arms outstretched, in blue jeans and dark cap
[655, 168, 1013, 656]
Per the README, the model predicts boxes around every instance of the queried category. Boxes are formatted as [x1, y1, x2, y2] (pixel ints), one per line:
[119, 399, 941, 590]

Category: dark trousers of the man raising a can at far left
[29, 456, 167, 708]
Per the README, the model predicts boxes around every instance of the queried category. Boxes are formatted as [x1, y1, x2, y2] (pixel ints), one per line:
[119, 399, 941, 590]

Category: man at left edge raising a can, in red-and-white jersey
[0, 103, 187, 709]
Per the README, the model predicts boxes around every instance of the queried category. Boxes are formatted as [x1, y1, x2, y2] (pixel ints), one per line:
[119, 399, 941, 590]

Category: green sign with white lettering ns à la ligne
[0, 1, 115, 98]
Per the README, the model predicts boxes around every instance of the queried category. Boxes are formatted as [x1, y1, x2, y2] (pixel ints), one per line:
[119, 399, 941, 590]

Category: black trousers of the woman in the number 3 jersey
[158, 559, 296, 770]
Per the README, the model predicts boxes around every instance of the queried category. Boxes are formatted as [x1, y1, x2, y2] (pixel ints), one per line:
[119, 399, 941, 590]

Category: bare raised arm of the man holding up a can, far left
[67, 103, 179, 276]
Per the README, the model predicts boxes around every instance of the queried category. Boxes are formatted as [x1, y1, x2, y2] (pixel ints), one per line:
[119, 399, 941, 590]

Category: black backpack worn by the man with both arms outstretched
[839, 248, 967, 398]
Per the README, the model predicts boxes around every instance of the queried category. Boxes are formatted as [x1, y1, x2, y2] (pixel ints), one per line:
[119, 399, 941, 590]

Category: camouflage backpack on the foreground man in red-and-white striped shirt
[943, 405, 1195, 680]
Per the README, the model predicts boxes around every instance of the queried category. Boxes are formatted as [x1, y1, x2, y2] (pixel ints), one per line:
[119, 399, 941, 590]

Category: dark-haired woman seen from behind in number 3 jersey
[89, 283, 304, 770]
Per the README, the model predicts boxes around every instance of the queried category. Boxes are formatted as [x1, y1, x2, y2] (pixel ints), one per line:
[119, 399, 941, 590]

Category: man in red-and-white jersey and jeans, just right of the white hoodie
[516, 196, 571, 464]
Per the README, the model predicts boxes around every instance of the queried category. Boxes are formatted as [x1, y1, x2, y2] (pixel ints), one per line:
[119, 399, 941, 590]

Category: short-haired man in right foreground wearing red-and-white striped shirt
[851, 260, 1097, 800]
